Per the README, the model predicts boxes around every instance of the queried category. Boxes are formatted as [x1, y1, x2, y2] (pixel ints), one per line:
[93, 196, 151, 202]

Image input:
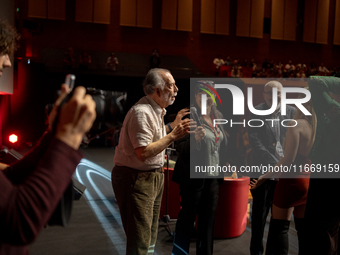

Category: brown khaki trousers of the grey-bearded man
[111, 166, 164, 255]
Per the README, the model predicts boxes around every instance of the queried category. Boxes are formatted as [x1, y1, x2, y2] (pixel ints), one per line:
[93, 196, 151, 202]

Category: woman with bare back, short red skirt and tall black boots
[251, 87, 316, 255]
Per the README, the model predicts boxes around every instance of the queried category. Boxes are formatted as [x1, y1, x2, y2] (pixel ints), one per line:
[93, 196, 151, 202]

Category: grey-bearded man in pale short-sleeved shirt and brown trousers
[112, 68, 190, 254]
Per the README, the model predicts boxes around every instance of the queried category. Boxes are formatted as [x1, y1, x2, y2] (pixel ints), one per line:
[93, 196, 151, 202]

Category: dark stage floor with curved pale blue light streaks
[30, 147, 298, 255]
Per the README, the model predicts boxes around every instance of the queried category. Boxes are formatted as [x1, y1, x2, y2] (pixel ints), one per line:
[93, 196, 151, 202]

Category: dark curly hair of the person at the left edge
[0, 19, 20, 55]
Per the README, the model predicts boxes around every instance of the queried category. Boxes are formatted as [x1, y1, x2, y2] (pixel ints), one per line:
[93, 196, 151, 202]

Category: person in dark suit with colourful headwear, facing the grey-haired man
[172, 80, 227, 255]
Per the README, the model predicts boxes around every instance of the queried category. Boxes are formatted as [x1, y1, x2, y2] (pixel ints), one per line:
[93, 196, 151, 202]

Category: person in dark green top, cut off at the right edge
[302, 73, 340, 255]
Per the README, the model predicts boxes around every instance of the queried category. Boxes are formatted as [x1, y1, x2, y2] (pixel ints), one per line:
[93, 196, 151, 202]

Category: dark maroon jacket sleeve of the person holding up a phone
[0, 134, 82, 255]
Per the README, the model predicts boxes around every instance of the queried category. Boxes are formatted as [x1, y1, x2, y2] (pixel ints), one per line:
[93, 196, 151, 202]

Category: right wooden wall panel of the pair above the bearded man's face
[177, 0, 193, 32]
